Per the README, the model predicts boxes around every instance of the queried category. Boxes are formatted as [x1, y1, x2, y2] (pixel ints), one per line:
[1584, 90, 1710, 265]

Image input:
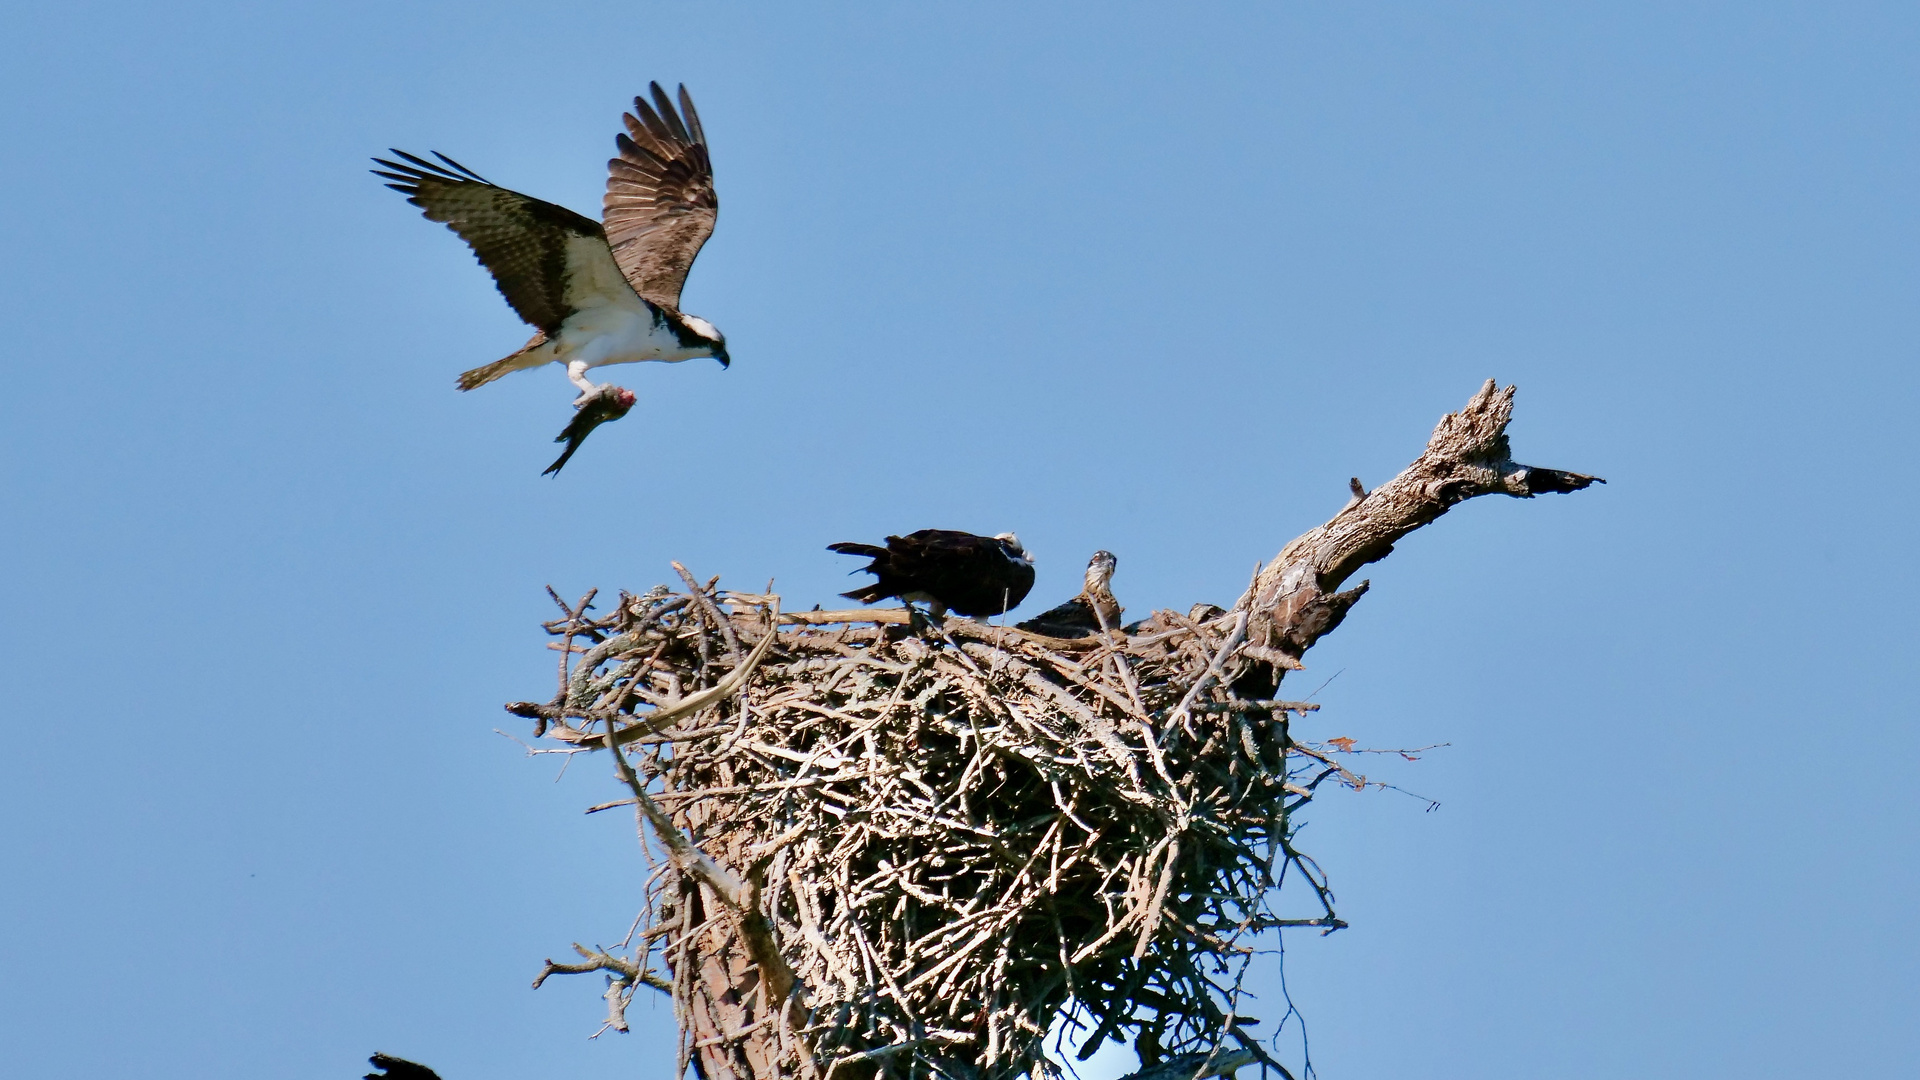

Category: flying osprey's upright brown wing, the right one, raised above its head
[601, 83, 720, 311]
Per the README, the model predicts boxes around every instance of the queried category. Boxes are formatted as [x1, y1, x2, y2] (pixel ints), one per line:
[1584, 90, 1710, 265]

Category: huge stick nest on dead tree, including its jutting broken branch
[509, 384, 1596, 1080]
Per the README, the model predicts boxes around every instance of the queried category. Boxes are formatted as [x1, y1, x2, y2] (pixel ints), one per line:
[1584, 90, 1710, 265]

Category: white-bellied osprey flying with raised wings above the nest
[372, 83, 730, 404]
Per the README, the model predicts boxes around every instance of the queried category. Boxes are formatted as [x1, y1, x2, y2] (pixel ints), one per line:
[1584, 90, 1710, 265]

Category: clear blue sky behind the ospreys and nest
[0, 0, 1920, 1080]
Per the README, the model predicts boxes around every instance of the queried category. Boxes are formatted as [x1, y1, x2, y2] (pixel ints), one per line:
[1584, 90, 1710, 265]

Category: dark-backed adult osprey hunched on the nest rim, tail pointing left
[828, 528, 1033, 617]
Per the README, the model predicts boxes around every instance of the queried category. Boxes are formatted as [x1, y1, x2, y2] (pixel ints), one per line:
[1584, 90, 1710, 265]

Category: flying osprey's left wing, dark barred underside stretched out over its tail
[372, 150, 607, 336]
